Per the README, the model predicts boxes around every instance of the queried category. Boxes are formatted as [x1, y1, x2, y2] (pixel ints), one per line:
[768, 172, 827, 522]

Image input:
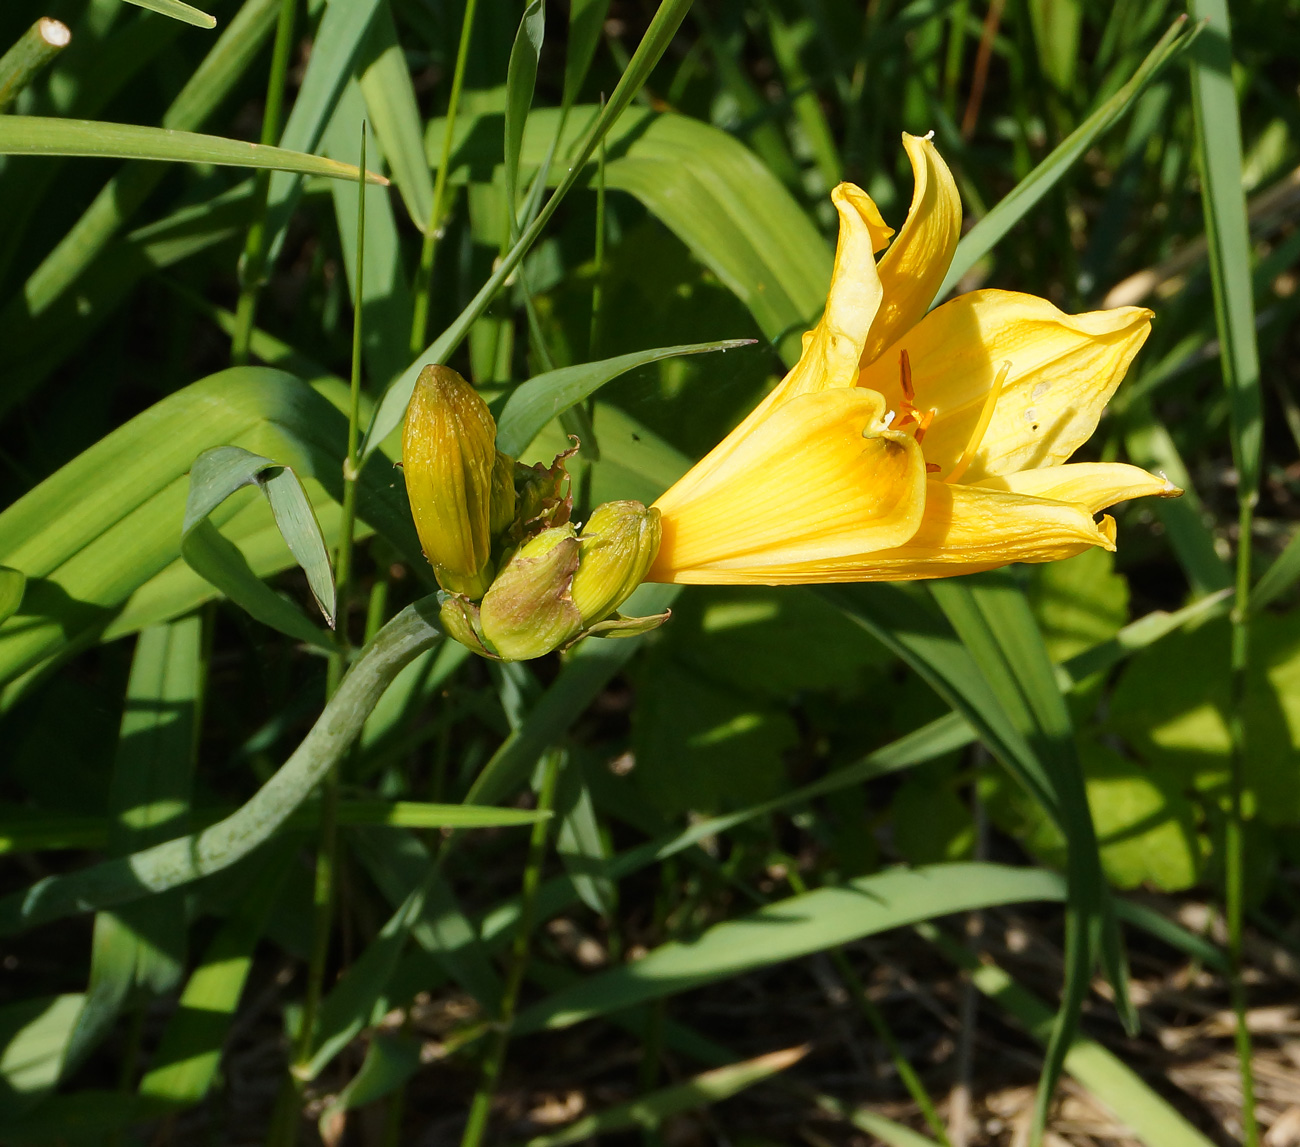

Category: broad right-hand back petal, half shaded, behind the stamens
[859, 290, 1152, 482]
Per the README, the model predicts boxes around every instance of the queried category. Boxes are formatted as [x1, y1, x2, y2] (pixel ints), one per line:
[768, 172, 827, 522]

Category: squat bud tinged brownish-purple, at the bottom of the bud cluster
[478, 525, 582, 661]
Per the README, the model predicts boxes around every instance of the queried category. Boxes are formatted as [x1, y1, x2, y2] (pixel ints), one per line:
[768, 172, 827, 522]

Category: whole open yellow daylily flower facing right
[647, 135, 1179, 584]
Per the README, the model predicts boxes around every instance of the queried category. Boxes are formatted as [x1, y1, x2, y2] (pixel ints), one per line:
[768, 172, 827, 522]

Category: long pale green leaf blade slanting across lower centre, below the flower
[515, 864, 1062, 1034]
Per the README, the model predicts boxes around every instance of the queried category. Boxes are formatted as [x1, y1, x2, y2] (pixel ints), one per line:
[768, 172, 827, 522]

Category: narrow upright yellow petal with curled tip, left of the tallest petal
[660, 183, 893, 504]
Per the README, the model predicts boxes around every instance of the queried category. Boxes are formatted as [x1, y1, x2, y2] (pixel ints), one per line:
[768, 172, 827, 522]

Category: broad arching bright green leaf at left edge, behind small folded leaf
[0, 367, 423, 680]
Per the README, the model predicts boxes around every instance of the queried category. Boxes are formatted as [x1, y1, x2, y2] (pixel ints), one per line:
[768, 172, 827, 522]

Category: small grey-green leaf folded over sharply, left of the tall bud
[181, 446, 335, 650]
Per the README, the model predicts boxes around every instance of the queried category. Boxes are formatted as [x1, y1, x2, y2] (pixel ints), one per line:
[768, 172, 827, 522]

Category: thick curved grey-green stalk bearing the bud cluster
[0, 598, 442, 935]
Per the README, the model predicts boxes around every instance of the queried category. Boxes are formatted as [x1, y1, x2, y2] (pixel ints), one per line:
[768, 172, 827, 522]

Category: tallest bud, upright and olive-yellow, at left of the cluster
[402, 367, 496, 600]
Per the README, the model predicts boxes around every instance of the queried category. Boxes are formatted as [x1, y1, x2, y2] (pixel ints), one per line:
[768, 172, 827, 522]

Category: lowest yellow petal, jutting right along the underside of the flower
[802, 480, 1115, 581]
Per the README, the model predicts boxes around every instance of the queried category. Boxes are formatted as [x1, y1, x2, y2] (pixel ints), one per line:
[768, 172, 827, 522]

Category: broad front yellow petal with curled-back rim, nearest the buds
[647, 389, 926, 585]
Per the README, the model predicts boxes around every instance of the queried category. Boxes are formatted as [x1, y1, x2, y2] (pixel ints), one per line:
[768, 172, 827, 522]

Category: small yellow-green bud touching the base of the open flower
[571, 502, 660, 627]
